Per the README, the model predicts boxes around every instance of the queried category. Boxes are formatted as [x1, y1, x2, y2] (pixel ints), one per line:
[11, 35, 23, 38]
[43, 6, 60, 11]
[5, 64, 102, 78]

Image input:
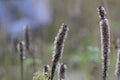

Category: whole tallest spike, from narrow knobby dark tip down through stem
[98, 6, 110, 80]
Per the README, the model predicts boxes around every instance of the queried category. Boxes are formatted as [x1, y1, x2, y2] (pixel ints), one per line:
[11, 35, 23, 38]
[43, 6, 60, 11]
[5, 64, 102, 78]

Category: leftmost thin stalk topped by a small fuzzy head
[17, 42, 24, 80]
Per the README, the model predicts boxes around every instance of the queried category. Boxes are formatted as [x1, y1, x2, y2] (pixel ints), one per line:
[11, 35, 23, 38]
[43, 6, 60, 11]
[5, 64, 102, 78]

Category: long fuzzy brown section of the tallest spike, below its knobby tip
[100, 19, 110, 62]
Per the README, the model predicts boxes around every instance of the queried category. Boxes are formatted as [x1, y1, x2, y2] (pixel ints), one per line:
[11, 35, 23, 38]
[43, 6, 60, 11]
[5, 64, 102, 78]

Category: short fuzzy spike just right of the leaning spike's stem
[58, 63, 67, 80]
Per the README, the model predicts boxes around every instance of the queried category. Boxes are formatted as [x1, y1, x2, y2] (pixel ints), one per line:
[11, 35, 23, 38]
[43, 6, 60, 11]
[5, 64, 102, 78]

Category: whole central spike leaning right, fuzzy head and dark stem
[50, 24, 68, 80]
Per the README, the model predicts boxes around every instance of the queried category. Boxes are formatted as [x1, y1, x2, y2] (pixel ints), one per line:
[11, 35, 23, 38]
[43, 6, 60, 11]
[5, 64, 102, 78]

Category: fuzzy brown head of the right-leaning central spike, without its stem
[52, 24, 69, 61]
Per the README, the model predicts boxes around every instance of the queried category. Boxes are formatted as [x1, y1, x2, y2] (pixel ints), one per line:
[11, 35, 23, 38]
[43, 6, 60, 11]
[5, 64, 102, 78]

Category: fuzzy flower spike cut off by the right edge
[115, 39, 120, 80]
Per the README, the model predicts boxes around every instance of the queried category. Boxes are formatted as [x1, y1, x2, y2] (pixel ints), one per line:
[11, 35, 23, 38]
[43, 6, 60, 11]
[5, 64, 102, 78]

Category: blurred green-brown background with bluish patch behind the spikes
[0, 0, 120, 80]
